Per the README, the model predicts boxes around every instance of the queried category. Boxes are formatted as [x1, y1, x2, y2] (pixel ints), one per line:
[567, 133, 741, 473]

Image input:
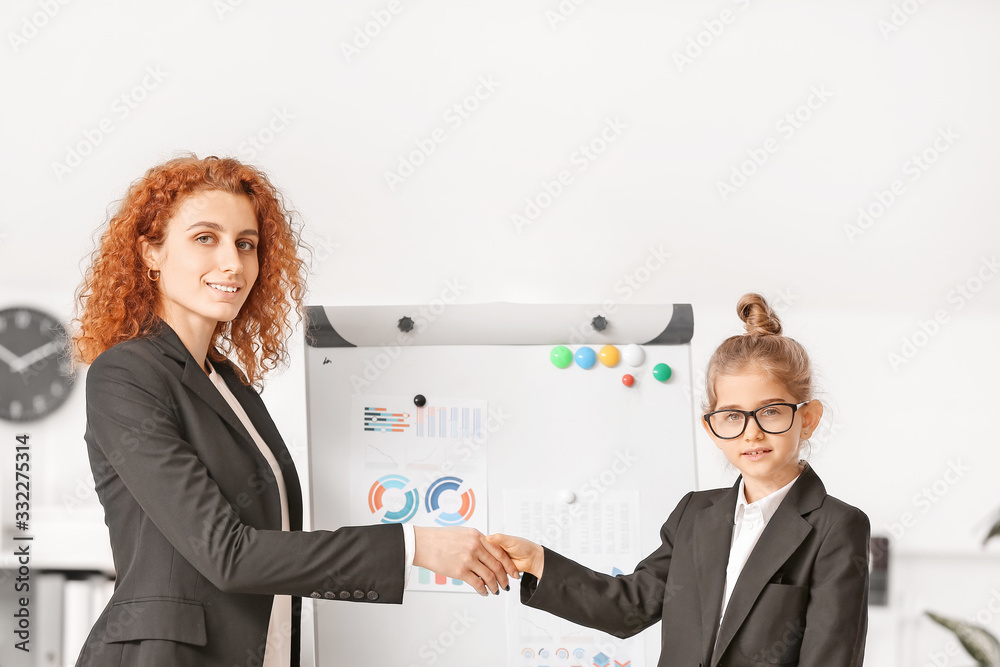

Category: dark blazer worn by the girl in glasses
[521, 465, 870, 667]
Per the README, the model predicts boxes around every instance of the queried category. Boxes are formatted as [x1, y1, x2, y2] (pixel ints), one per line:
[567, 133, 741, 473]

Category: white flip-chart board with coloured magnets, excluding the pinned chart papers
[305, 303, 696, 666]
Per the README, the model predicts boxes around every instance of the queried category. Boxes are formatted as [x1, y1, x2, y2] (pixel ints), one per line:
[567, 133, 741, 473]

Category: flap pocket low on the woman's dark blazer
[104, 597, 207, 646]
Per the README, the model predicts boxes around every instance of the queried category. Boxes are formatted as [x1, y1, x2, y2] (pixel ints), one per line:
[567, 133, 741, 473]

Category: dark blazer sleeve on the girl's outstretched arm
[521, 493, 692, 638]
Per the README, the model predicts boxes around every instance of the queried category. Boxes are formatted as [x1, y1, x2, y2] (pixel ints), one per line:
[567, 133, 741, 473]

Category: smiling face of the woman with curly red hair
[140, 190, 259, 338]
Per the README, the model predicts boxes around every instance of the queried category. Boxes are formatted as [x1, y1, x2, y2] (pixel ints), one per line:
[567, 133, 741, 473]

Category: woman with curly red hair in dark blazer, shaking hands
[74, 156, 517, 667]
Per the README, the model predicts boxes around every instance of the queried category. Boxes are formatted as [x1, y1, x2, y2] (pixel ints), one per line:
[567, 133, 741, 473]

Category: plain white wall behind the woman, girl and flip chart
[0, 0, 1000, 665]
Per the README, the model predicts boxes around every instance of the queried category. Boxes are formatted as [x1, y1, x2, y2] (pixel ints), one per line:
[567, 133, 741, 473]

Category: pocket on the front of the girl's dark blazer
[737, 584, 809, 665]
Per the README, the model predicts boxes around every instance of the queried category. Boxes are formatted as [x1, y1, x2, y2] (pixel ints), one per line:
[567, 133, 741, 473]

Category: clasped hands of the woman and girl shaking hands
[413, 526, 544, 595]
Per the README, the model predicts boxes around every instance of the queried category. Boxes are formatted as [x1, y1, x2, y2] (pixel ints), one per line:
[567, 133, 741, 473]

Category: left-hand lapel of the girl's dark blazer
[694, 480, 739, 655]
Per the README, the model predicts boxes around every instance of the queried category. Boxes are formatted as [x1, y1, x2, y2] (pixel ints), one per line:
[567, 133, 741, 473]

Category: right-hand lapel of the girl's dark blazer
[712, 464, 826, 666]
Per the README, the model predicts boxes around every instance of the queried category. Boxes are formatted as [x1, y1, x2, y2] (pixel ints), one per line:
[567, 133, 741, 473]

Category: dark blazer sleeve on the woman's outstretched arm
[87, 348, 404, 603]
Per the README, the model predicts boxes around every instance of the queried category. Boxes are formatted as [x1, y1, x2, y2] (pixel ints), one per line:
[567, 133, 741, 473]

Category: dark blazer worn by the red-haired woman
[77, 323, 404, 667]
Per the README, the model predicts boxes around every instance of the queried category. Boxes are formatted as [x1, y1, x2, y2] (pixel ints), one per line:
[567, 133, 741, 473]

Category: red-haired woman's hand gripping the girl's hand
[413, 526, 519, 595]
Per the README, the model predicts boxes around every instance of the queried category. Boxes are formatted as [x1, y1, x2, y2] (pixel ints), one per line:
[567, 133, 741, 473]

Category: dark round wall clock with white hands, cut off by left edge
[0, 308, 73, 422]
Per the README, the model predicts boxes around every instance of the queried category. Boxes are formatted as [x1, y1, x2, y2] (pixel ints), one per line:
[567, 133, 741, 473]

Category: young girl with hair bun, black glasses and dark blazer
[489, 294, 870, 667]
